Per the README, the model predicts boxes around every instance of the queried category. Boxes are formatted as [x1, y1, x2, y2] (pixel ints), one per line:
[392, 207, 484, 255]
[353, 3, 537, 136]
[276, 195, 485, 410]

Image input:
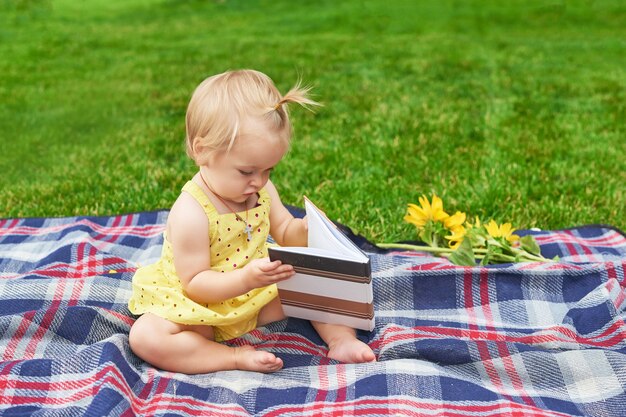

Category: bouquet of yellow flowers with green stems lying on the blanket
[378, 195, 557, 266]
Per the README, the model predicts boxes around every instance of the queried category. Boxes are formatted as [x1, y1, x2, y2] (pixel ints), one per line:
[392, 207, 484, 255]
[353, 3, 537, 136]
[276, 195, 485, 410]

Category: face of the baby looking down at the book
[201, 119, 287, 204]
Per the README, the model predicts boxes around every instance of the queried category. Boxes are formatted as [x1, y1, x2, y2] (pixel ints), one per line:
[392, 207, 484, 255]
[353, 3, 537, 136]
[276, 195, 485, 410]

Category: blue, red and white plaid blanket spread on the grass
[0, 211, 626, 416]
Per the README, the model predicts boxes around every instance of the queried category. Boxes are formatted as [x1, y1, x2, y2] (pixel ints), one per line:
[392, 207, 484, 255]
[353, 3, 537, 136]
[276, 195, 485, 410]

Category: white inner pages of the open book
[304, 197, 368, 262]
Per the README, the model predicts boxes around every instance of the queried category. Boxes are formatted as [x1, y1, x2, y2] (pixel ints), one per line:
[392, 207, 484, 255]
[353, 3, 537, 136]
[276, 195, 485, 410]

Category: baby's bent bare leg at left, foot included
[129, 313, 283, 374]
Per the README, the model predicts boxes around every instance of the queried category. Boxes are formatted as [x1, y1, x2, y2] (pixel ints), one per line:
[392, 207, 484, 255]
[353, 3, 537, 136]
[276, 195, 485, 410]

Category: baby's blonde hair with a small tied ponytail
[185, 70, 320, 165]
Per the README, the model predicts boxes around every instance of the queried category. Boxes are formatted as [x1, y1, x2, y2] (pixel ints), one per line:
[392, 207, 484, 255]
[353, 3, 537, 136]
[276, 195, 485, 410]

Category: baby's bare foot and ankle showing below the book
[311, 321, 376, 363]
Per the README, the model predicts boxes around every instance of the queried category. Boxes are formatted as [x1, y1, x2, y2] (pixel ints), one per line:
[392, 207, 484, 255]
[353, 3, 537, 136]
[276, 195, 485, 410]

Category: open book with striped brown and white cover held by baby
[269, 197, 374, 331]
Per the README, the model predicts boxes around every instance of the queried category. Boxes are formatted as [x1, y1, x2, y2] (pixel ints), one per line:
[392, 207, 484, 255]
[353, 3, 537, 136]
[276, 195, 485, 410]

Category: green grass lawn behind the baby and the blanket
[0, 0, 626, 241]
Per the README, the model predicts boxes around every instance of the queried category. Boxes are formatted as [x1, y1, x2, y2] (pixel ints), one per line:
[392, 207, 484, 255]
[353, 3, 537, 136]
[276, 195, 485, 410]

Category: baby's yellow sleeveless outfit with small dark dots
[128, 181, 278, 341]
